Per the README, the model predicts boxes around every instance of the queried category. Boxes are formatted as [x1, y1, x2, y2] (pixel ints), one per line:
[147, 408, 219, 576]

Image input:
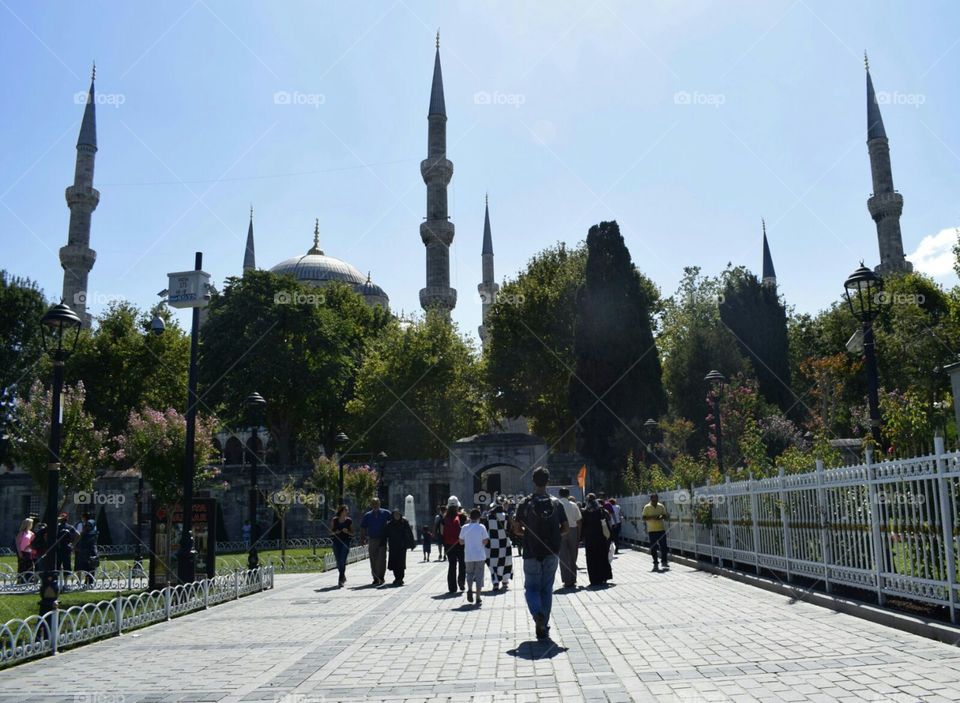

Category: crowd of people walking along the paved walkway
[330, 467, 669, 639]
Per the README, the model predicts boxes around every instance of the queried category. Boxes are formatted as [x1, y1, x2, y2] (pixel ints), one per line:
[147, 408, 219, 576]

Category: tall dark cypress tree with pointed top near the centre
[570, 222, 666, 486]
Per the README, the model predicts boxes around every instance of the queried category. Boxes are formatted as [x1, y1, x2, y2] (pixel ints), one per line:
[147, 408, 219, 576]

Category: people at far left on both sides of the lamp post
[14, 512, 100, 584]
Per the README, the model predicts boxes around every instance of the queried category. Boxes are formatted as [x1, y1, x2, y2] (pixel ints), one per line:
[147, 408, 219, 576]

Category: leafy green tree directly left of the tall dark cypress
[484, 244, 587, 450]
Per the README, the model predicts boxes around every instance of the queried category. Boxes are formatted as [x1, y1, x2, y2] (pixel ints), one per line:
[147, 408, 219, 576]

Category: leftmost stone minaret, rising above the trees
[60, 64, 100, 327]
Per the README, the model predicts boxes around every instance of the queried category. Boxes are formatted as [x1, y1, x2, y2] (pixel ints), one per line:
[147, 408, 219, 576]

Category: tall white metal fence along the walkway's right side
[621, 437, 960, 623]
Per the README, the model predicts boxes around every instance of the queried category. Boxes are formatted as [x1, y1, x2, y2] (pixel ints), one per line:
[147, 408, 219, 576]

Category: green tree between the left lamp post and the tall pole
[66, 302, 190, 435]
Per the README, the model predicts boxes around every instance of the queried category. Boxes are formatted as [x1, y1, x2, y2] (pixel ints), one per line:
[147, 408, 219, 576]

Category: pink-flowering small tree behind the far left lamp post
[12, 381, 108, 500]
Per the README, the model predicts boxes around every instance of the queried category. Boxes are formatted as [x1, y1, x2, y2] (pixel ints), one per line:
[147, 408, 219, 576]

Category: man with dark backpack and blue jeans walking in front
[517, 466, 569, 640]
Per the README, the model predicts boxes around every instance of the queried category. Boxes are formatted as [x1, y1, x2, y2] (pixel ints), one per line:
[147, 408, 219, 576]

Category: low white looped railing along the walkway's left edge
[0, 566, 273, 667]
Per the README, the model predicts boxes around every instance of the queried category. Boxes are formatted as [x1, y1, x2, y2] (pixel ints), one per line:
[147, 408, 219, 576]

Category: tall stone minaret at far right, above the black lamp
[863, 52, 913, 274]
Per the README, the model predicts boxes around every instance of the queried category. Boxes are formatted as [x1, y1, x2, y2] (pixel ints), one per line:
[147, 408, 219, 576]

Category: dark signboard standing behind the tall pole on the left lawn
[150, 498, 217, 590]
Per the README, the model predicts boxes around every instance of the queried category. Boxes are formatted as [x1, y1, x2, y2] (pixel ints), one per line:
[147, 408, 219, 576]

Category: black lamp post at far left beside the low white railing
[40, 303, 83, 615]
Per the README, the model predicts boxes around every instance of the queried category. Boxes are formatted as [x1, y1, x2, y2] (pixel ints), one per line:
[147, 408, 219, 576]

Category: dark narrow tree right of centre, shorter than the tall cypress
[719, 266, 796, 412]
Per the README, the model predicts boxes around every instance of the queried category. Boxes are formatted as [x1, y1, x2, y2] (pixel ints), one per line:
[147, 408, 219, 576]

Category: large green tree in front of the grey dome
[200, 271, 388, 464]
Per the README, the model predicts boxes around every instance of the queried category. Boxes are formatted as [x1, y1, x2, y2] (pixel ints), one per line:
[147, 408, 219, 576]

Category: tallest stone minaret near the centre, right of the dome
[420, 32, 457, 318]
